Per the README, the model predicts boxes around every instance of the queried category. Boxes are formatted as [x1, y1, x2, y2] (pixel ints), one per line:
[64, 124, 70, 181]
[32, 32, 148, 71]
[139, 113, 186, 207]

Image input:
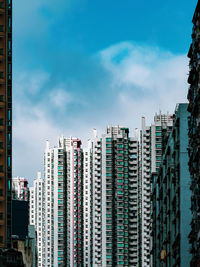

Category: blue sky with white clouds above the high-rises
[13, 0, 197, 184]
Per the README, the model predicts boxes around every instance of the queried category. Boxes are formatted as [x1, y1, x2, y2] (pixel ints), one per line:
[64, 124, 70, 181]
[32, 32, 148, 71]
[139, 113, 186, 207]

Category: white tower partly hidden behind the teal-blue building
[139, 113, 173, 267]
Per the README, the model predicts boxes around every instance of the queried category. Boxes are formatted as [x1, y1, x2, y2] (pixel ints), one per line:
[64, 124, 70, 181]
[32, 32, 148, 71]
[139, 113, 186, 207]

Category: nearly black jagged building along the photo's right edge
[188, 1, 200, 266]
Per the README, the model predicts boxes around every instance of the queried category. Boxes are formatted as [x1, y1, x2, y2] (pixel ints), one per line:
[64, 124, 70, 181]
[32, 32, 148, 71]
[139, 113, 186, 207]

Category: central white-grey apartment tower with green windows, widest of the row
[84, 126, 139, 266]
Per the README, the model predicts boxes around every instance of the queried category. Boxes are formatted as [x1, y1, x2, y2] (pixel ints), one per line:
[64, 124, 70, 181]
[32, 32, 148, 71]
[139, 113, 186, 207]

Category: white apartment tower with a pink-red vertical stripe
[43, 137, 83, 267]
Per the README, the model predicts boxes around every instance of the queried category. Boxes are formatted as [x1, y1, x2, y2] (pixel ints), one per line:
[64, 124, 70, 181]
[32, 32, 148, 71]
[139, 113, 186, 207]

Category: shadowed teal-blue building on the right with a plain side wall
[152, 104, 192, 267]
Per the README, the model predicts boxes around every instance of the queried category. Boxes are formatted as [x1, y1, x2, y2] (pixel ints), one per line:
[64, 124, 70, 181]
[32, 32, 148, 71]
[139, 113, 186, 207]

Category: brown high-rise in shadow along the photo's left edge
[0, 0, 12, 248]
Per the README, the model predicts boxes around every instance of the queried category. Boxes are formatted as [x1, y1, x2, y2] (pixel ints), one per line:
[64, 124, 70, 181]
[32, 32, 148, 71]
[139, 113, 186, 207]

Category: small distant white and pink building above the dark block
[12, 177, 28, 201]
